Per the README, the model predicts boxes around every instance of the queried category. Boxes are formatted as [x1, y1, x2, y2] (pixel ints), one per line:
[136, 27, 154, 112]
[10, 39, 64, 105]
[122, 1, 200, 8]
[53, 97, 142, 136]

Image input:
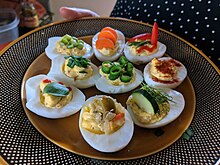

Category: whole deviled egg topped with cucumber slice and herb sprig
[127, 84, 185, 128]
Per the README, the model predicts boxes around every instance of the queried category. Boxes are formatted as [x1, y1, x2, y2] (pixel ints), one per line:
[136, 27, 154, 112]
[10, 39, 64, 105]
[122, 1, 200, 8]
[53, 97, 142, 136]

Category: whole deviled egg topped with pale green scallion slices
[45, 34, 93, 59]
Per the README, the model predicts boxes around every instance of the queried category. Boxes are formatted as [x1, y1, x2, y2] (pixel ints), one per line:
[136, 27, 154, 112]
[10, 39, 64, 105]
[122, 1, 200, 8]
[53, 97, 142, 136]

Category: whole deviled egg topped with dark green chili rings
[95, 56, 143, 94]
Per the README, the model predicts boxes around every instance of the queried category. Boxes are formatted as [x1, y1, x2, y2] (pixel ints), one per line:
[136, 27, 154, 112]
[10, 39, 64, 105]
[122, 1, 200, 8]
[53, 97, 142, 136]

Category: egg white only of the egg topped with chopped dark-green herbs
[47, 56, 100, 88]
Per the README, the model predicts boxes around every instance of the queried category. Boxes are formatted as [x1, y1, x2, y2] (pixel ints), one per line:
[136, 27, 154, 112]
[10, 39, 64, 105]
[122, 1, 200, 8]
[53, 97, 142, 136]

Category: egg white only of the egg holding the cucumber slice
[127, 88, 185, 128]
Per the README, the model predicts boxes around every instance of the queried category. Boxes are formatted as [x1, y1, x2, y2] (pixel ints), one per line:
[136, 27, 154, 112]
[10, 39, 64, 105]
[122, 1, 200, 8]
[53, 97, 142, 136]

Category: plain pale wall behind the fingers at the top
[49, 0, 116, 22]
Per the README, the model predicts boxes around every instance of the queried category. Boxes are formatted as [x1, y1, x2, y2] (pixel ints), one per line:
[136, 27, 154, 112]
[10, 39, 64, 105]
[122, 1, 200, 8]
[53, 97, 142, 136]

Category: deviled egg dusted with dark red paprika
[144, 57, 187, 88]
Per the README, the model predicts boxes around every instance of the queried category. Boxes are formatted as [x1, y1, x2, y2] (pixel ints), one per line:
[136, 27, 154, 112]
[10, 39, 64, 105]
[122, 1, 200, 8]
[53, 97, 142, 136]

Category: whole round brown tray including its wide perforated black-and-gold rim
[0, 17, 220, 164]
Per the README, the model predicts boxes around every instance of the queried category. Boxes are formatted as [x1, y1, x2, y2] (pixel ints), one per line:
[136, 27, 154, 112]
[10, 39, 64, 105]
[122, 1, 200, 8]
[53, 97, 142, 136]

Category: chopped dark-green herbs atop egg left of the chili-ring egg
[64, 56, 90, 68]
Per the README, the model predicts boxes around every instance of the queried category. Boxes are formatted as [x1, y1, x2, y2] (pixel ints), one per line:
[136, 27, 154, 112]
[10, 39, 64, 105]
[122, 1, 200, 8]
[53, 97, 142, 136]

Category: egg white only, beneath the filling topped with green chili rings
[95, 69, 143, 94]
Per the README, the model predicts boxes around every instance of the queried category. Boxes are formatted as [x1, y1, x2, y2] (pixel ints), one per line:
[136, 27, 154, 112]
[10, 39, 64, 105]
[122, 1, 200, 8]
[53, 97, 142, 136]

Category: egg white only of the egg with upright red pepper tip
[124, 42, 167, 65]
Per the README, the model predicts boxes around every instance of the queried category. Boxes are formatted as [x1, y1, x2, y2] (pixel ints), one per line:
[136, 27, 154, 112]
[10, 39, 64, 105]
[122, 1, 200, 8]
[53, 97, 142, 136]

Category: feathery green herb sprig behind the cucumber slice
[141, 83, 174, 104]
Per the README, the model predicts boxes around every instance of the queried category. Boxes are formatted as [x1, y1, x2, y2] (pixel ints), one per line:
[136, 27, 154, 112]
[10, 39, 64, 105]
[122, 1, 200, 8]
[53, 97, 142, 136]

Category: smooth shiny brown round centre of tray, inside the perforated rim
[21, 36, 196, 160]
